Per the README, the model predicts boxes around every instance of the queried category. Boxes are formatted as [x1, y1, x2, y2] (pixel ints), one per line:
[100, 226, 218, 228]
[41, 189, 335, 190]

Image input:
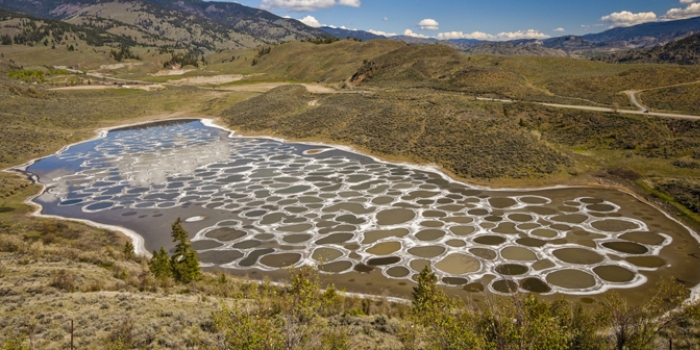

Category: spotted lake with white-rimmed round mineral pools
[20, 120, 700, 295]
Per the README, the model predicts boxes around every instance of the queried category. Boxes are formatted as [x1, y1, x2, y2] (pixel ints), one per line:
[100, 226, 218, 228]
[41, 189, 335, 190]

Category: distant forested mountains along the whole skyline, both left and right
[0, 0, 700, 58]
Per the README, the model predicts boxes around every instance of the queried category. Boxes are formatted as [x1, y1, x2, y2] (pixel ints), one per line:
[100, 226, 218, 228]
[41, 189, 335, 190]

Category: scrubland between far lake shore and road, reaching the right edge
[222, 86, 700, 230]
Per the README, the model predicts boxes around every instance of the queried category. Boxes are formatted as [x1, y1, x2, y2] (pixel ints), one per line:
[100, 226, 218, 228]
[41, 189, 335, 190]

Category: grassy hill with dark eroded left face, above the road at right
[350, 46, 700, 106]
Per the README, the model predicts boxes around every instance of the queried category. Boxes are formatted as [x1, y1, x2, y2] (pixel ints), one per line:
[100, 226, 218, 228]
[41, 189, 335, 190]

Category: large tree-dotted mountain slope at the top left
[0, 0, 328, 51]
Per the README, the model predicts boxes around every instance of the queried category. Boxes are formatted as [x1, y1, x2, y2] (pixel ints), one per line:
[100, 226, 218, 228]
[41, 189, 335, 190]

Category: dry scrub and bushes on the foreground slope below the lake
[0, 204, 700, 349]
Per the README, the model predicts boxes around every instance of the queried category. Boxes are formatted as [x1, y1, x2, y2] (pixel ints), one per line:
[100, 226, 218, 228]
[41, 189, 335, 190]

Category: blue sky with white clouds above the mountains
[219, 0, 700, 40]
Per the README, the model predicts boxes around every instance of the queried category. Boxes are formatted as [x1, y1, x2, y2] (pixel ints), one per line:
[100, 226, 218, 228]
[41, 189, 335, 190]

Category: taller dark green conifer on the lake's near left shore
[170, 218, 202, 283]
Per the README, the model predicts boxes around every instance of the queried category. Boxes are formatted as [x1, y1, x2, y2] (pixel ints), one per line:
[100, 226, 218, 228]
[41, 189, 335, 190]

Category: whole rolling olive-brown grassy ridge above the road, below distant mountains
[241, 40, 700, 107]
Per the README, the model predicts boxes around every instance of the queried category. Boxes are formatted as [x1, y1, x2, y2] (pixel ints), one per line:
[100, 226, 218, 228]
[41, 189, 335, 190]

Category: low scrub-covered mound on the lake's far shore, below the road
[223, 87, 570, 179]
